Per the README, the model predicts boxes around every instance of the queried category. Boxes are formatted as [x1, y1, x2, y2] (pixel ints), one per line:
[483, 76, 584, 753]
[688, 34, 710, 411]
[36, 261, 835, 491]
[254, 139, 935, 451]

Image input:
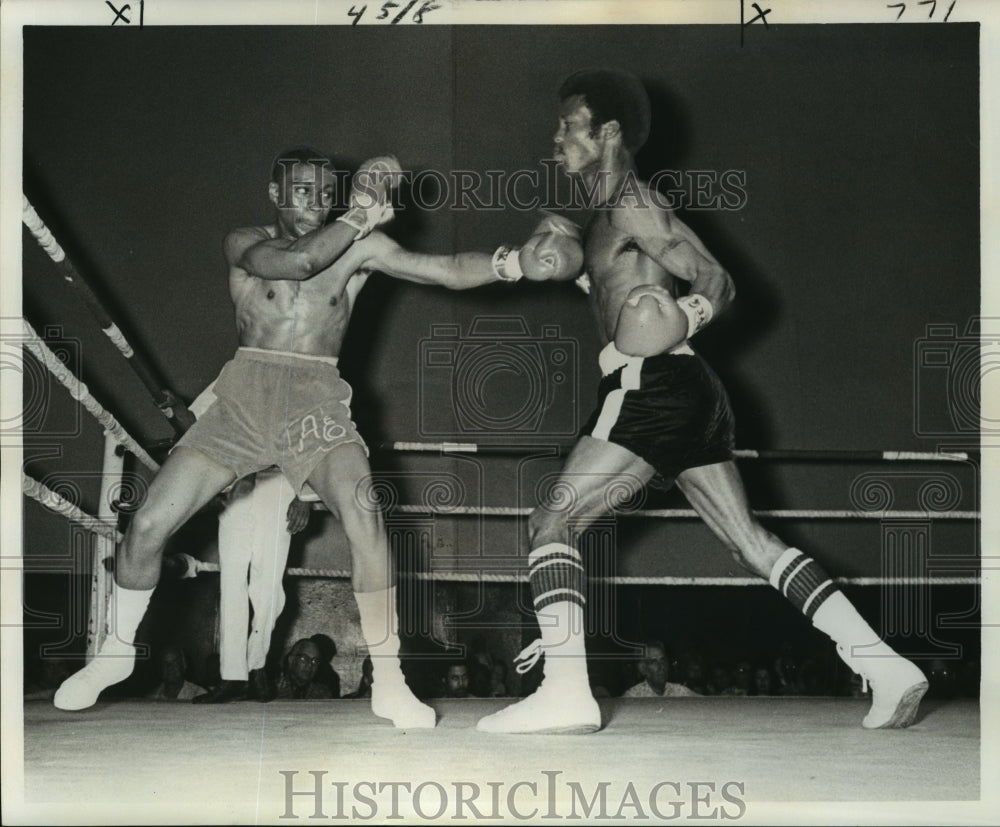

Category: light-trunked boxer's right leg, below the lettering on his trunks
[300, 450, 436, 728]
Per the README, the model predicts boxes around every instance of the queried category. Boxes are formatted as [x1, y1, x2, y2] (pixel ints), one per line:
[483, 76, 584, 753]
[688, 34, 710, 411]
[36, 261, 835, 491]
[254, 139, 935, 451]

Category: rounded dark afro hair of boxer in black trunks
[559, 68, 651, 153]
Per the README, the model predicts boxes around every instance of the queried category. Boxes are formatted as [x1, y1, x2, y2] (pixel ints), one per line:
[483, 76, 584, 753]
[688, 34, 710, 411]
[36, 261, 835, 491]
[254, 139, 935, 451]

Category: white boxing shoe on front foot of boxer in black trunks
[476, 680, 601, 735]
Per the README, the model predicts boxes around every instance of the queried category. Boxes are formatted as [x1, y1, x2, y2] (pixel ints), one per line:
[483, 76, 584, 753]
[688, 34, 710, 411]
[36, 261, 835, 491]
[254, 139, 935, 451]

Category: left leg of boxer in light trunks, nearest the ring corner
[53, 447, 235, 710]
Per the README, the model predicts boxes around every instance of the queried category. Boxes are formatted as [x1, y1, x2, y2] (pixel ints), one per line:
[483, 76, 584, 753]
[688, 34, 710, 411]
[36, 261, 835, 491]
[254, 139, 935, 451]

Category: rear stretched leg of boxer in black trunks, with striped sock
[677, 462, 927, 729]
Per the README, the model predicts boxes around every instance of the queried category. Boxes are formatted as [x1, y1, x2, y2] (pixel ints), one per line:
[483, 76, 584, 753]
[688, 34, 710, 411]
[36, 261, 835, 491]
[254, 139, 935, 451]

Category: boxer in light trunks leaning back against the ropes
[54, 148, 572, 727]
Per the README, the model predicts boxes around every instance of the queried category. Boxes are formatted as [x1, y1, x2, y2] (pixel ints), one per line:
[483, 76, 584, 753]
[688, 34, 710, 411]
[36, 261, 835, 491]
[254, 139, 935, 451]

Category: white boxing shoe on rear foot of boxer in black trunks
[837, 644, 928, 729]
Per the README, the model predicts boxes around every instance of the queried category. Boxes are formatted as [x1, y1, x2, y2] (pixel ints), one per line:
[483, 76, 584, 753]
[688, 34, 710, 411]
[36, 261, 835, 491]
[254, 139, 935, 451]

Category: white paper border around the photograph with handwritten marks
[0, 0, 1000, 824]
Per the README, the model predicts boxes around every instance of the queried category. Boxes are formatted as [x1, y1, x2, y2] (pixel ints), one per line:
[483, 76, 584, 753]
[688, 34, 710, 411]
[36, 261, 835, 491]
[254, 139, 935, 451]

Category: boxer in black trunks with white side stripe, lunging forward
[366, 69, 927, 733]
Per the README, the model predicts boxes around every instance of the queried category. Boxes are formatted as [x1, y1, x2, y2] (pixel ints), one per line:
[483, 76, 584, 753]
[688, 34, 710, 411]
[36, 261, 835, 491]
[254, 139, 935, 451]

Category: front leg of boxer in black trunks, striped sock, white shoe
[478, 436, 654, 733]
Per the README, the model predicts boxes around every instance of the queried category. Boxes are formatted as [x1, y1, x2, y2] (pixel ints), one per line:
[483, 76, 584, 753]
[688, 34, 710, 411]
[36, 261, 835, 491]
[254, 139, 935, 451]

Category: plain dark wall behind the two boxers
[19, 24, 979, 680]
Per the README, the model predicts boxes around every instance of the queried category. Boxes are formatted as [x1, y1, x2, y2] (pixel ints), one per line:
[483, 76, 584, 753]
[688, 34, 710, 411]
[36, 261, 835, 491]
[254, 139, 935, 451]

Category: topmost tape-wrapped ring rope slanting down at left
[21, 193, 194, 436]
